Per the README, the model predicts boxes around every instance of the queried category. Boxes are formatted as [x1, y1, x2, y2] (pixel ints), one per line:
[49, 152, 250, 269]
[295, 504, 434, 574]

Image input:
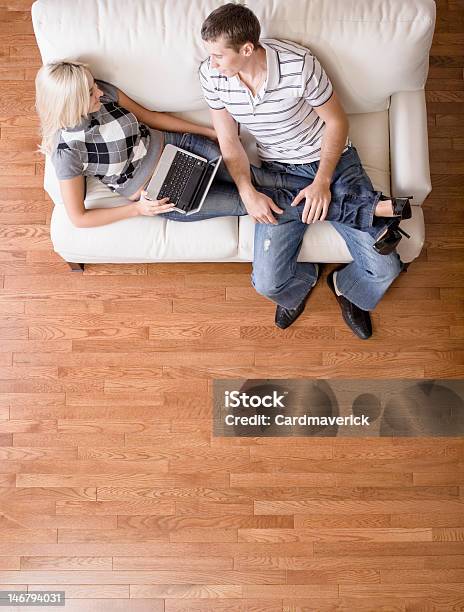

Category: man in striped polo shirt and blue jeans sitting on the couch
[199, 3, 401, 339]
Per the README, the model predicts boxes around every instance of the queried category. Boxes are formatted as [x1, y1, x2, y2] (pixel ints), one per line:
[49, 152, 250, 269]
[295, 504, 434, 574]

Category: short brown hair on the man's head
[201, 2, 261, 51]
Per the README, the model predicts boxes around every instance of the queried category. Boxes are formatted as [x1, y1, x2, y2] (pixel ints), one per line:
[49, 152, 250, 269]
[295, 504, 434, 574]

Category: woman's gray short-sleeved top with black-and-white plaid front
[51, 81, 164, 196]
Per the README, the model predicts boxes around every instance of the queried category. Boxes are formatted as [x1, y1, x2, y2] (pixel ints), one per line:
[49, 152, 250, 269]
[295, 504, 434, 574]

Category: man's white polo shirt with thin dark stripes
[199, 38, 348, 164]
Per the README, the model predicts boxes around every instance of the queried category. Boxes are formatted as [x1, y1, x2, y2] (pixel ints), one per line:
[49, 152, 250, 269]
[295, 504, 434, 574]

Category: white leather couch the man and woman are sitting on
[32, 0, 435, 263]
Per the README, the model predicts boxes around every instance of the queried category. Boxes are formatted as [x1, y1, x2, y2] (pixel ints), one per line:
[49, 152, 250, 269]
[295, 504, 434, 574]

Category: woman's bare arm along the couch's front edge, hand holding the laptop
[60, 176, 174, 227]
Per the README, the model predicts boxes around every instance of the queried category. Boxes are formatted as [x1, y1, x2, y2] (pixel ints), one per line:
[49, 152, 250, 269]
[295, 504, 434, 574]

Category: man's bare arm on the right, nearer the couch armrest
[293, 92, 348, 223]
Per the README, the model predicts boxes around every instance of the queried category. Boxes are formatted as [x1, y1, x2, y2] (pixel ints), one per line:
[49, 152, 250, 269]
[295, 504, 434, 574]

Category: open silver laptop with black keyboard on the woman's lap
[146, 144, 222, 215]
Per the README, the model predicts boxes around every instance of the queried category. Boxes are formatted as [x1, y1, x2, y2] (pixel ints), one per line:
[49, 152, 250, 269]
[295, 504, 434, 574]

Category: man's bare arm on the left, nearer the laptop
[210, 108, 283, 225]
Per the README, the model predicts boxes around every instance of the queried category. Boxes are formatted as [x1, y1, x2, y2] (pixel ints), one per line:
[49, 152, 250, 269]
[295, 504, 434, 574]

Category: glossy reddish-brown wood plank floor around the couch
[0, 0, 464, 612]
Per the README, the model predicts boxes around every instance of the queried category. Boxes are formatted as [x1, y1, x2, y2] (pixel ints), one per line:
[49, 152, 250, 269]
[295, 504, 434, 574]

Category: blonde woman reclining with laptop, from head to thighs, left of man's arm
[36, 61, 252, 227]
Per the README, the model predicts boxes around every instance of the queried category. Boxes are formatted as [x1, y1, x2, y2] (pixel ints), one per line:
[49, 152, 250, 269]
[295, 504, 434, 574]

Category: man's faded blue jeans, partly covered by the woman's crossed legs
[252, 147, 401, 310]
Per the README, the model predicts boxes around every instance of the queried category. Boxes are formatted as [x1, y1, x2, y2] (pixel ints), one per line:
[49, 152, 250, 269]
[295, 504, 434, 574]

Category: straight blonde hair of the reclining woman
[35, 60, 90, 155]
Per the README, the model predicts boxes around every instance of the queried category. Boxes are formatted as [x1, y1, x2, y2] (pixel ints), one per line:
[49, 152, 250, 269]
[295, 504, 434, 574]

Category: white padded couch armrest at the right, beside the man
[389, 89, 432, 204]
